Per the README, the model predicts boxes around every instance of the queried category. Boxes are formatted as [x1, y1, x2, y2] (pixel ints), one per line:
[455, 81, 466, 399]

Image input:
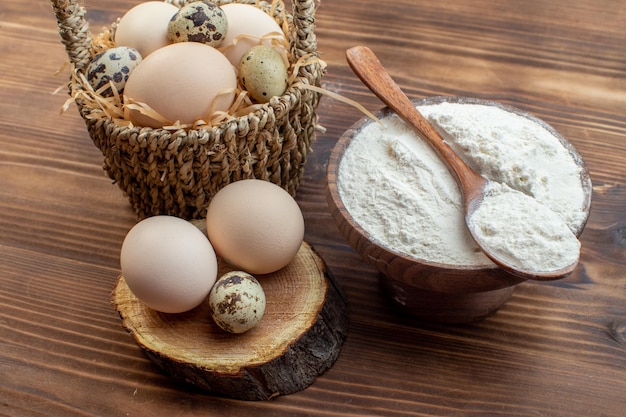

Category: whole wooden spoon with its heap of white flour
[346, 46, 580, 280]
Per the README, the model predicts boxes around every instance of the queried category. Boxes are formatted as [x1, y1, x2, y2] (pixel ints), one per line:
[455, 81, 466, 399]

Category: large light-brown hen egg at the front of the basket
[124, 42, 237, 128]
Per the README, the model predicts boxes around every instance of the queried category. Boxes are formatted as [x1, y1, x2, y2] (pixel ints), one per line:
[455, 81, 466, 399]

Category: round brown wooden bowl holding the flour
[327, 97, 591, 323]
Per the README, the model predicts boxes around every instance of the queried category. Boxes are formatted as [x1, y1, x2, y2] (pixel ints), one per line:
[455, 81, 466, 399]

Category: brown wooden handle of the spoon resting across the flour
[346, 46, 485, 202]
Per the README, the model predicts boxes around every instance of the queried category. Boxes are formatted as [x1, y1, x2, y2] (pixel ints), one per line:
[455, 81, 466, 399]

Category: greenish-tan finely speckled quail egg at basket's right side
[238, 45, 288, 103]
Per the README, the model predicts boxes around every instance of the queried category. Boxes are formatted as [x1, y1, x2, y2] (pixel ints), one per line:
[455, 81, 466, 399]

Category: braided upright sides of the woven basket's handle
[51, 0, 317, 69]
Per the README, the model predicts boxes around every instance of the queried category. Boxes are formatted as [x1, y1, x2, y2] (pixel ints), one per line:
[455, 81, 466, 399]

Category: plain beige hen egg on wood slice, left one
[120, 216, 218, 313]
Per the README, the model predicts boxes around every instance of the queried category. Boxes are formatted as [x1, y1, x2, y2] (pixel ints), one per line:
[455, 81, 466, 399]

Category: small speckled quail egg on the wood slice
[209, 271, 265, 333]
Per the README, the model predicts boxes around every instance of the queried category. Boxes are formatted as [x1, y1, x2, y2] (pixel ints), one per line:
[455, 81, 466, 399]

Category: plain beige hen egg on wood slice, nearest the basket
[206, 179, 304, 274]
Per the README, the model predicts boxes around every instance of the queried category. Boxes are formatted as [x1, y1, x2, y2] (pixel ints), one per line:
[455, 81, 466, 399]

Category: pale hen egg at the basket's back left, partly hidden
[115, 1, 178, 58]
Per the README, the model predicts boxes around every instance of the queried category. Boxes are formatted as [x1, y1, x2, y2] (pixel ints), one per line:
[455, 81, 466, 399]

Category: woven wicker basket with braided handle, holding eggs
[52, 0, 324, 219]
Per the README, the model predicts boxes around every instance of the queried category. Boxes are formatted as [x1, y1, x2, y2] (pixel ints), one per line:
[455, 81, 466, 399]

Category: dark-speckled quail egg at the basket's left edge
[87, 46, 141, 97]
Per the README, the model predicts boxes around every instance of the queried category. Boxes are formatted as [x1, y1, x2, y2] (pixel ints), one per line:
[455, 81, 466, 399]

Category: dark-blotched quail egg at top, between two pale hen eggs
[167, 1, 228, 47]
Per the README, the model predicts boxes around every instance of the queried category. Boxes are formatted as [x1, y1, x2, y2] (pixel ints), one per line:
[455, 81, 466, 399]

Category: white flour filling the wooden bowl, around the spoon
[338, 103, 586, 266]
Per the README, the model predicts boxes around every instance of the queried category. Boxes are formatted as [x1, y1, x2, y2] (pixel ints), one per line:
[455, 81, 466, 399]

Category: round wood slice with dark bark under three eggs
[111, 243, 348, 400]
